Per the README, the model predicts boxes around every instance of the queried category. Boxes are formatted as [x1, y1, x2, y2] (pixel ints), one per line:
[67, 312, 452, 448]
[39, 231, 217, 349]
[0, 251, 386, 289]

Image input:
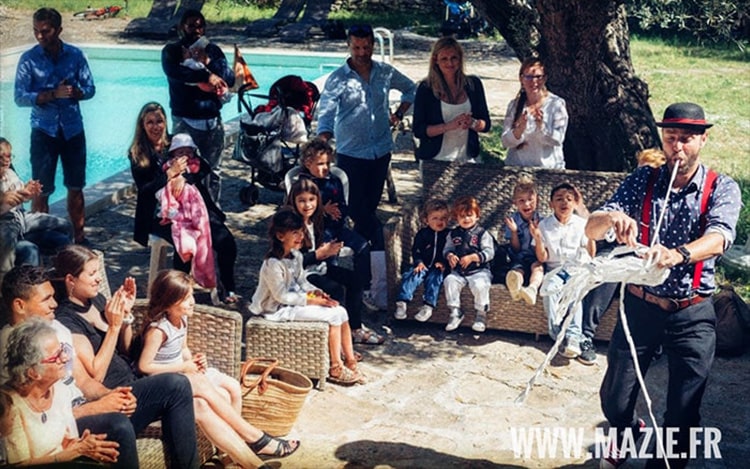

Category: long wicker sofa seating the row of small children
[385, 161, 626, 340]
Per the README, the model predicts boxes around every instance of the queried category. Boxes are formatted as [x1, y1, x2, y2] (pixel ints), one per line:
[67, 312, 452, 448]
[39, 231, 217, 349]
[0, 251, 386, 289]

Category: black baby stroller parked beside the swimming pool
[233, 75, 320, 205]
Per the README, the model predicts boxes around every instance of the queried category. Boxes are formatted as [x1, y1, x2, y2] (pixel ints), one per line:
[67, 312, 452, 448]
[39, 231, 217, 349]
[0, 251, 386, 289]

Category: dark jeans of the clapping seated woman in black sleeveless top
[130, 373, 199, 469]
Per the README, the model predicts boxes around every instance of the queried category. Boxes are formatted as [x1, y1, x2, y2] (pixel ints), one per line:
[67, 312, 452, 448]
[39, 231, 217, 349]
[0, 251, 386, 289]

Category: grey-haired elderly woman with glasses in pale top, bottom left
[5, 319, 119, 465]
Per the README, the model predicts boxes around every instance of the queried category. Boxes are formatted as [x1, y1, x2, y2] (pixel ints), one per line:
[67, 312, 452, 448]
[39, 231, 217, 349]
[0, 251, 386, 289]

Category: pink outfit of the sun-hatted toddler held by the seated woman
[156, 180, 216, 288]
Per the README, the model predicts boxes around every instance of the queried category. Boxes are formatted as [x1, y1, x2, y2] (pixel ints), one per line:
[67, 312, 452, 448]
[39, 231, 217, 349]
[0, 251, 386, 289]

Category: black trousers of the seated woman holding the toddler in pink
[151, 219, 237, 292]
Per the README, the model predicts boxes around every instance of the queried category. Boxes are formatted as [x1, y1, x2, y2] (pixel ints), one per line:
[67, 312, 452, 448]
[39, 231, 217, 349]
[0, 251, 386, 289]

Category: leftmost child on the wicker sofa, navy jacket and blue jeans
[394, 199, 450, 322]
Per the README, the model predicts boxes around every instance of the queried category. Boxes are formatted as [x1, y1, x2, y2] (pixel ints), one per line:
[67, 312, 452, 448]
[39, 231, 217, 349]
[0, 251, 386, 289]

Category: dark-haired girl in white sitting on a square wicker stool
[249, 207, 363, 385]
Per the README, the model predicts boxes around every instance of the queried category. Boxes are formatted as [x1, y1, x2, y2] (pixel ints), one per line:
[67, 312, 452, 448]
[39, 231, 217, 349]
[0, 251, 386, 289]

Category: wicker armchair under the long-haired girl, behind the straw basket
[133, 299, 242, 468]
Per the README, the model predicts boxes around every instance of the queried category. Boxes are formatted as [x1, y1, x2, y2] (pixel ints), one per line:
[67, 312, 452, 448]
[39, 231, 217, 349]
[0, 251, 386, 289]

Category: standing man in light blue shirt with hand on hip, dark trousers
[318, 25, 416, 308]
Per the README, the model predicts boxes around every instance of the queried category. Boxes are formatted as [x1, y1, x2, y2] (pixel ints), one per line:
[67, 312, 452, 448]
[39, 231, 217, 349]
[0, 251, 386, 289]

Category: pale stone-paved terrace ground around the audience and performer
[0, 6, 750, 468]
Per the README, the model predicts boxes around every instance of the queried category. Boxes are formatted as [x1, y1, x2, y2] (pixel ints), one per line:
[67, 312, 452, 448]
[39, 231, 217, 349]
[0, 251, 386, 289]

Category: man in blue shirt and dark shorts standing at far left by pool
[15, 8, 96, 243]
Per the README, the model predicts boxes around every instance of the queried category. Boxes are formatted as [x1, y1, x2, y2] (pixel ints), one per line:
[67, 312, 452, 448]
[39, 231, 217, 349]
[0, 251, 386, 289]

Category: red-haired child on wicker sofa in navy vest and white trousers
[443, 196, 495, 332]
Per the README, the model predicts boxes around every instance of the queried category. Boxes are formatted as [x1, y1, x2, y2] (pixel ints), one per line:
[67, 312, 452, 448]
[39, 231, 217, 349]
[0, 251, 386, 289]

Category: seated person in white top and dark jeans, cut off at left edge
[0, 137, 73, 280]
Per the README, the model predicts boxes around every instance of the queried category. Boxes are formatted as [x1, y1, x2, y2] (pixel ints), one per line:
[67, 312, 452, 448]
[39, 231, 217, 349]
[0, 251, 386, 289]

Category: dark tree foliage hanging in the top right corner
[626, 0, 750, 49]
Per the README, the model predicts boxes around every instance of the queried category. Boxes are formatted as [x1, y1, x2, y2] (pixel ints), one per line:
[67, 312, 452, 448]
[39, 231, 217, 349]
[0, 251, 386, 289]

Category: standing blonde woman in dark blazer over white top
[413, 37, 491, 161]
